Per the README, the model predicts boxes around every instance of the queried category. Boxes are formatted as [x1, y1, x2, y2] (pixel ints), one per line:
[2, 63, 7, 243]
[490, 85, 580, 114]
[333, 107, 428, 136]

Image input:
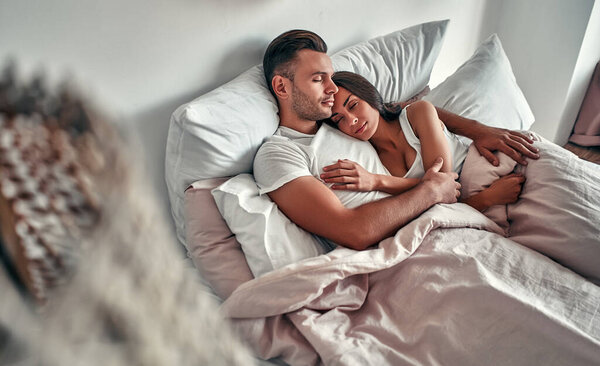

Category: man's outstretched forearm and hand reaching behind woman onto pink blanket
[436, 107, 539, 165]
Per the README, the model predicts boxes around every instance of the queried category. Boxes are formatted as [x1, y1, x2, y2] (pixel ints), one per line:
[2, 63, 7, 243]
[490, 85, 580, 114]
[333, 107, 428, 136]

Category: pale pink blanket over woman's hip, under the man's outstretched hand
[460, 135, 600, 284]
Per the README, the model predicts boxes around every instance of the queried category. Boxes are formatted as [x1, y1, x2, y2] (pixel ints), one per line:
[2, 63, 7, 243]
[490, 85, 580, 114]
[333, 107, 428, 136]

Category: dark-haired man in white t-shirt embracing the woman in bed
[254, 30, 537, 250]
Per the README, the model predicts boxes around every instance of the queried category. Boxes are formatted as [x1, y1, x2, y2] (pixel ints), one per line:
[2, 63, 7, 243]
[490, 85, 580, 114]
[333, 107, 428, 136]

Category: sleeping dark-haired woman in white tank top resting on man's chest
[321, 71, 525, 211]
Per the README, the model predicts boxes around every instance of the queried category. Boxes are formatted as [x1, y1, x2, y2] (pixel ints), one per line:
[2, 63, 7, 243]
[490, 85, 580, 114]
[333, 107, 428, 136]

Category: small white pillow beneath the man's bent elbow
[212, 174, 326, 277]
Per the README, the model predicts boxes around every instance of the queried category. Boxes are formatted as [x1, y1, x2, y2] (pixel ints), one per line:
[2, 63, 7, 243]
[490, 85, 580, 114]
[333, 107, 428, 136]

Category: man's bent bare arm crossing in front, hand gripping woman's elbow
[269, 159, 460, 250]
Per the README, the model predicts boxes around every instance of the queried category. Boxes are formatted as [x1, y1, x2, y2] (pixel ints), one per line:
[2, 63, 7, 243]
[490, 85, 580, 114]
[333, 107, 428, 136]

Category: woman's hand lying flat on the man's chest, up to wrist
[321, 159, 378, 192]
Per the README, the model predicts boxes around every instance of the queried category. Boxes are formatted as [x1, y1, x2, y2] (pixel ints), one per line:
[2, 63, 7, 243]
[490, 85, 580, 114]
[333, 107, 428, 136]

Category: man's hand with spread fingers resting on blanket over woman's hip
[469, 124, 540, 166]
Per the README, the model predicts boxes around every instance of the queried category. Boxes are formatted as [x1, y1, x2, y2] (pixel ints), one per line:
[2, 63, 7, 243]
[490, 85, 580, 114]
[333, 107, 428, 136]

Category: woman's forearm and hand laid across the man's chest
[321, 159, 421, 194]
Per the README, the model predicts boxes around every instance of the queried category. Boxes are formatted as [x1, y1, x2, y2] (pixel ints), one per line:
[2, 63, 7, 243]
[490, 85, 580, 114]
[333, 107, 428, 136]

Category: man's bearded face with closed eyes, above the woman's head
[290, 50, 338, 121]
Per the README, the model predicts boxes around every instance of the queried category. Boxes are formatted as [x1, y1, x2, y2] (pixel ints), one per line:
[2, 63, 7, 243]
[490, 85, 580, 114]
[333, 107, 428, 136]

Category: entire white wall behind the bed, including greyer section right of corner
[0, 0, 598, 227]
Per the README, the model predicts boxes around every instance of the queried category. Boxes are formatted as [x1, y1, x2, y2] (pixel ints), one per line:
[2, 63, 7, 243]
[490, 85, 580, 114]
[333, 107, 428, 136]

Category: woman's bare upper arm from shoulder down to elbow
[406, 100, 452, 172]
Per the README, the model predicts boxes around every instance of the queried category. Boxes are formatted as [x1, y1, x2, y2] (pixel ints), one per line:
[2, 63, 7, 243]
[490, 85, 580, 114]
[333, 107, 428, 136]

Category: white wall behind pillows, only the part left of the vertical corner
[0, 0, 494, 226]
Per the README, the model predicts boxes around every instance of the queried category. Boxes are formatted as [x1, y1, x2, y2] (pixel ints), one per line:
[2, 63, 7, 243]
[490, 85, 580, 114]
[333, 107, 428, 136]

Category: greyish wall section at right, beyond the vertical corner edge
[496, 0, 598, 144]
